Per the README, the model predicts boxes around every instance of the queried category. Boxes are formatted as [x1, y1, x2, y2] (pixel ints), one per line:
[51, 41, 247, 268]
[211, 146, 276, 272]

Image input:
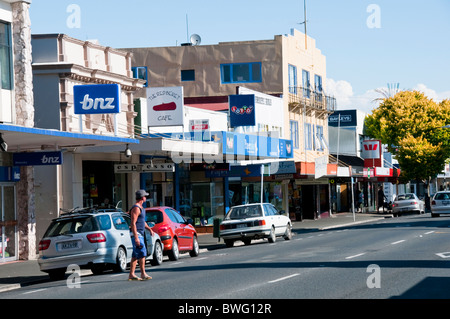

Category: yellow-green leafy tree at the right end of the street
[364, 91, 450, 181]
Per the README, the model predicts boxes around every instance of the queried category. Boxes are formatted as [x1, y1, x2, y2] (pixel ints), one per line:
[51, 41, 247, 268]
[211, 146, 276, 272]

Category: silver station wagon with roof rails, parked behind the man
[38, 208, 163, 279]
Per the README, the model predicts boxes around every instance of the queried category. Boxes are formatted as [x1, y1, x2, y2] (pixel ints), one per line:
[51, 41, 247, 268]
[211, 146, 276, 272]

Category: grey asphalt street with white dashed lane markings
[1, 214, 450, 302]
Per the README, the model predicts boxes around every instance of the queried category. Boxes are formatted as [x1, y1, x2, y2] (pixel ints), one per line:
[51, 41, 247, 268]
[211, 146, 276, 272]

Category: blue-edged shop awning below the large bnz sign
[0, 124, 139, 152]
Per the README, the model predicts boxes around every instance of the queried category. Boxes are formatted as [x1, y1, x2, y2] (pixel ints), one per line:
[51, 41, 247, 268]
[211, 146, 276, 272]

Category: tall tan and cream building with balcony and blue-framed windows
[124, 30, 336, 218]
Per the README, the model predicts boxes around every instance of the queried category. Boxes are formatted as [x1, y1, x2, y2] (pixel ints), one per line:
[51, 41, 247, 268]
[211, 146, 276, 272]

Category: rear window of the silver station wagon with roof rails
[44, 216, 100, 237]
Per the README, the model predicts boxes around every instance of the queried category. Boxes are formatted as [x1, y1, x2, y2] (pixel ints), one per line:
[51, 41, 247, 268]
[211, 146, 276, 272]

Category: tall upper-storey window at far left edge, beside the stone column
[0, 21, 13, 90]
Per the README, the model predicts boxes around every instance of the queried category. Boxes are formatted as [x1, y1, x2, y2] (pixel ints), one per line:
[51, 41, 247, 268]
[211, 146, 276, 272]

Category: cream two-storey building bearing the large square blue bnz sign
[31, 34, 145, 254]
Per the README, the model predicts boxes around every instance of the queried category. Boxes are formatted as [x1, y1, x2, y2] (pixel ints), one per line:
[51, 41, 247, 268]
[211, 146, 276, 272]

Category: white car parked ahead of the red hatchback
[219, 203, 292, 247]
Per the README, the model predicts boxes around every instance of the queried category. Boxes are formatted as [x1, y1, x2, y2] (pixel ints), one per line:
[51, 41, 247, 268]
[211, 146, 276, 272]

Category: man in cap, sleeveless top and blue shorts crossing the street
[128, 189, 153, 280]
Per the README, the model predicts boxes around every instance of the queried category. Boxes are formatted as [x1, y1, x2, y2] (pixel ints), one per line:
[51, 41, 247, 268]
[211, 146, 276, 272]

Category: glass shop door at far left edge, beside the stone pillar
[0, 184, 17, 262]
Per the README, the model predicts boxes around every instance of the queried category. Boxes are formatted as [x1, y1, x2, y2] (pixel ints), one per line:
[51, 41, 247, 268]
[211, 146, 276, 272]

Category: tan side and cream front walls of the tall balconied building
[124, 30, 328, 162]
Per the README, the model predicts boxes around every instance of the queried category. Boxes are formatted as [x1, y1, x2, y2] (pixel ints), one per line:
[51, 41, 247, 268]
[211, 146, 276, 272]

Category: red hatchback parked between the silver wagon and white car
[145, 206, 199, 260]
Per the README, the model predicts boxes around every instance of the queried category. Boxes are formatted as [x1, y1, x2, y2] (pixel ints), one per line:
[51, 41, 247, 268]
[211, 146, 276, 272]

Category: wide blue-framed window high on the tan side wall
[220, 62, 262, 83]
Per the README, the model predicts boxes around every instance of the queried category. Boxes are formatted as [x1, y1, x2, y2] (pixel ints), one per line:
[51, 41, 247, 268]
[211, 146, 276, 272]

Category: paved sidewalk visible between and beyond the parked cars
[0, 213, 392, 293]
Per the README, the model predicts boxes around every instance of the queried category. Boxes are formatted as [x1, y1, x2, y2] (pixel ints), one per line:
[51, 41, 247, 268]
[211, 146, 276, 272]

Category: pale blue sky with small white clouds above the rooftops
[30, 0, 450, 112]
